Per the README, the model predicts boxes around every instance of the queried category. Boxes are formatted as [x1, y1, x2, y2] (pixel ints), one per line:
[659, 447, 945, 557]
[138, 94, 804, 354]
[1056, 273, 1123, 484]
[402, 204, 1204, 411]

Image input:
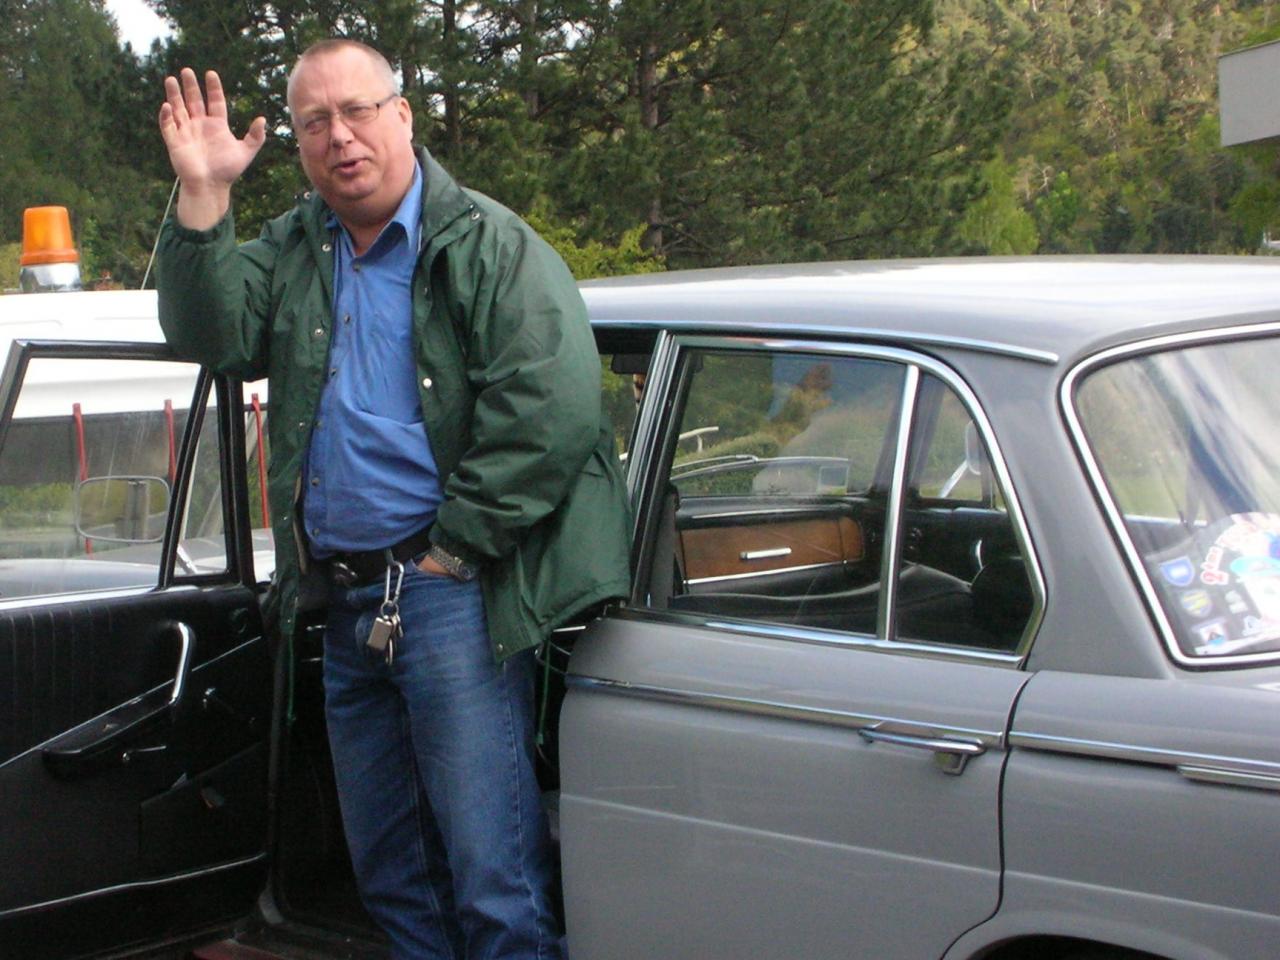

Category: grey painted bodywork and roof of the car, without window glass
[561, 257, 1280, 960]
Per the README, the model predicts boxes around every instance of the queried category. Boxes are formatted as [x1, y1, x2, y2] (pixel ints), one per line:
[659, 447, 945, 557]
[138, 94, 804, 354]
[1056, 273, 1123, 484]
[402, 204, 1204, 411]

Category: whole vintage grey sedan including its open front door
[0, 259, 1280, 960]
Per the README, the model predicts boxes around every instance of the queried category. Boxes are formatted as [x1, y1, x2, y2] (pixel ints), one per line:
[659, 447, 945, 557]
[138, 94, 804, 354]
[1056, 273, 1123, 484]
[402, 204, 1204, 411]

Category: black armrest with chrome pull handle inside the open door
[41, 621, 196, 778]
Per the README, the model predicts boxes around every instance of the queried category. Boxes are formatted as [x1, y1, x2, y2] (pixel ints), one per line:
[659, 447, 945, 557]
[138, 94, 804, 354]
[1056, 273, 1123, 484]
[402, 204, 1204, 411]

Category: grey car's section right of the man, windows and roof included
[561, 259, 1280, 960]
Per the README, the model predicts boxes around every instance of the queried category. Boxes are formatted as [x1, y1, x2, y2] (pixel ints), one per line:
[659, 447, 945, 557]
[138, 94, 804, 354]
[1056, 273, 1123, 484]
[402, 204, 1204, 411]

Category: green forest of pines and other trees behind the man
[0, 0, 1280, 288]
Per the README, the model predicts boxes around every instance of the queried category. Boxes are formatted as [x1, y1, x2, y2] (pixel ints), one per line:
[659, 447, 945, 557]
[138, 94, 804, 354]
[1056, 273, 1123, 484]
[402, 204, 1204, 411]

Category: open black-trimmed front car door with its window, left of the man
[0, 343, 271, 957]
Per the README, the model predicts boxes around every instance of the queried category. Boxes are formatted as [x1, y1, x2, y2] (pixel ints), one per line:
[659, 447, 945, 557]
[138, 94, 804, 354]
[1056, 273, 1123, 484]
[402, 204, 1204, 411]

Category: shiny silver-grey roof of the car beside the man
[581, 256, 1280, 362]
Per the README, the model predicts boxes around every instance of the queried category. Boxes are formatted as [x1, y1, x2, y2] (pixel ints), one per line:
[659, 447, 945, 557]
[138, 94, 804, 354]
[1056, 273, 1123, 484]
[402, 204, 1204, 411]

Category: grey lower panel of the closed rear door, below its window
[561, 618, 1027, 960]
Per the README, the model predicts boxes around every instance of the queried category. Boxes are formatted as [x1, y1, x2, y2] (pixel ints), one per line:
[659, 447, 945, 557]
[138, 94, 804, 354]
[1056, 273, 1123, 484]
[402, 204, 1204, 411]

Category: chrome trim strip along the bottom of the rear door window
[609, 607, 1023, 667]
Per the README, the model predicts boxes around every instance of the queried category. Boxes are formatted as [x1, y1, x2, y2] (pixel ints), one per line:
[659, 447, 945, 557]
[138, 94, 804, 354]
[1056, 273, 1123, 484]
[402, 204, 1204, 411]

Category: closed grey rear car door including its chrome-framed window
[561, 337, 1042, 960]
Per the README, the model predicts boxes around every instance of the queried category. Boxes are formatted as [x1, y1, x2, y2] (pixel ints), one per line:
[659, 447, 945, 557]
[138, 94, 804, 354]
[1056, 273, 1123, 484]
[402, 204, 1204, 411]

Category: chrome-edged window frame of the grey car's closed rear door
[620, 332, 1046, 667]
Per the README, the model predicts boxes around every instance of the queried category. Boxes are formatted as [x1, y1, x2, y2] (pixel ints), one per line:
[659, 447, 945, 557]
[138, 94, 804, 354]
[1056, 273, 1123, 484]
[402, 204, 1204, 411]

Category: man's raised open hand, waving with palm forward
[160, 67, 266, 229]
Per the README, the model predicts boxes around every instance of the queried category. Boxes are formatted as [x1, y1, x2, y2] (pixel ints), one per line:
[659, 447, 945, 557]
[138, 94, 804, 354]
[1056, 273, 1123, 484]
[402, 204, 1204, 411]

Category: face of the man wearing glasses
[289, 47, 416, 225]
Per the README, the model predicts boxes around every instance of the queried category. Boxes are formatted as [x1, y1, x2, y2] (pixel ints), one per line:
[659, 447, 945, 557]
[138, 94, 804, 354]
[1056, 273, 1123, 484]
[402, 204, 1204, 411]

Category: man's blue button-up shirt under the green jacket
[302, 169, 443, 557]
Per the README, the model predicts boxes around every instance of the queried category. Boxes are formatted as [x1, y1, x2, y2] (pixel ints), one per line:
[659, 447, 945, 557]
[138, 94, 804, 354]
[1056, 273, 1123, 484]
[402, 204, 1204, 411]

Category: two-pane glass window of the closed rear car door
[645, 351, 1033, 652]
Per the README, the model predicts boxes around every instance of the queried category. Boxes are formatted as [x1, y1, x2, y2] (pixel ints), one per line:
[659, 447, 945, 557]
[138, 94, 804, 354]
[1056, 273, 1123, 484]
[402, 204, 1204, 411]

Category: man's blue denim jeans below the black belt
[324, 563, 561, 960]
